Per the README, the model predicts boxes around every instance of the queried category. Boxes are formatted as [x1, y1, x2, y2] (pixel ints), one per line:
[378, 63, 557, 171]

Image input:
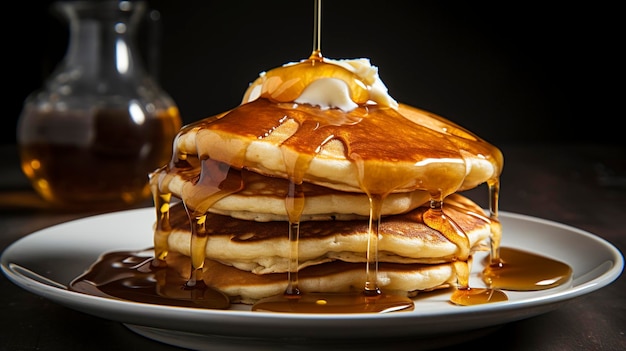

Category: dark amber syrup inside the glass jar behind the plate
[18, 108, 181, 208]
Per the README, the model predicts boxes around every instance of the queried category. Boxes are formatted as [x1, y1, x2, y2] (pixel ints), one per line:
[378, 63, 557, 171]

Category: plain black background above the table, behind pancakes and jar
[0, 0, 625, 145]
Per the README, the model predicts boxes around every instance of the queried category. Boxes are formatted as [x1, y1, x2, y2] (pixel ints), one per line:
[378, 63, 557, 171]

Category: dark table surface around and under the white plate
[0, 144, 626, 351]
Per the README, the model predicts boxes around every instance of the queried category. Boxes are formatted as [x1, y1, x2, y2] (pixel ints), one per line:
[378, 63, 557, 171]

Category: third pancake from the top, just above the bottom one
[162, 194, 490, 274]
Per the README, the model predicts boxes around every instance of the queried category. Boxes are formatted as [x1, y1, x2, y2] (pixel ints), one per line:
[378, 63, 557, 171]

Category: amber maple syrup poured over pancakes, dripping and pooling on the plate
[71, 2, 572, 313]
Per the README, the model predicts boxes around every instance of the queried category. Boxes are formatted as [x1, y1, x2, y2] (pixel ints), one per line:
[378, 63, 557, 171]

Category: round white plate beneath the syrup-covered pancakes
[1, 208, 624, 350]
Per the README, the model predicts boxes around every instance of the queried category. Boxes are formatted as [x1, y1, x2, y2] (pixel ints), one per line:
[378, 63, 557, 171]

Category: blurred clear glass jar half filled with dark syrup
[17, 1, 182, 209]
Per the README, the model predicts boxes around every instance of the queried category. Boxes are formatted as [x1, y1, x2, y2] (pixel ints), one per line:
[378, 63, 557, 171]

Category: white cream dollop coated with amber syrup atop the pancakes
[242, 58, 398, 112]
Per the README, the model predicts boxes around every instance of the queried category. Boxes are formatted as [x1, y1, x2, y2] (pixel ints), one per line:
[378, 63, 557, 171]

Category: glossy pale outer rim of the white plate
[0, 207, 624, 338]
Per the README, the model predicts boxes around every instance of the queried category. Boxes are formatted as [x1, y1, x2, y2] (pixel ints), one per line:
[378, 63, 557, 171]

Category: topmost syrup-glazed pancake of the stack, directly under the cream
[175, 98, 503, 196]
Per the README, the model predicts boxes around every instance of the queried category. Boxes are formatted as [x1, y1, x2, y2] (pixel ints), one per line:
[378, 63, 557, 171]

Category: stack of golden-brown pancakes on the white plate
[151, 58, 503, 303]
